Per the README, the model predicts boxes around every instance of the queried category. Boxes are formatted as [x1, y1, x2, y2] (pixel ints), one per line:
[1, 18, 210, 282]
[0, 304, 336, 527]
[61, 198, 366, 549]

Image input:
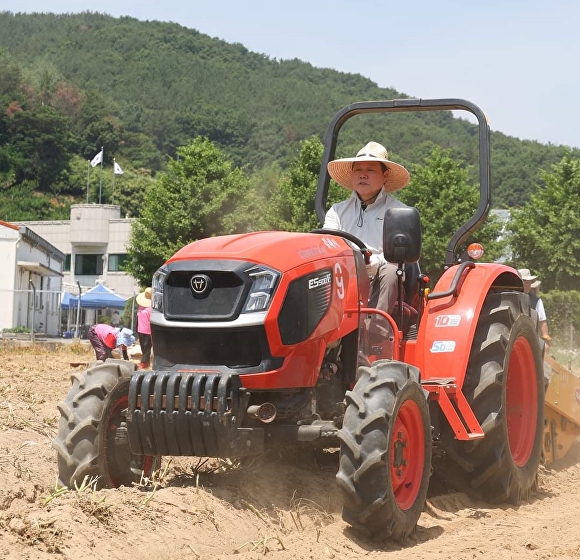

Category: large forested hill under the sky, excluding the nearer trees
[0, 12, 565, 219]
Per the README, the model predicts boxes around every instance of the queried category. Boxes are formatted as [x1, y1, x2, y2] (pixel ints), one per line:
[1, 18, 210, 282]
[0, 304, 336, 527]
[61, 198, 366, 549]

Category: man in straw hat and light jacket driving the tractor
[323, 142, 411, 314]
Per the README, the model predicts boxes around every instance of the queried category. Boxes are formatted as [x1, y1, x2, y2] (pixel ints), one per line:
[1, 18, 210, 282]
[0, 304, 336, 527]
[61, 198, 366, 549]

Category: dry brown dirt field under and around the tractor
[0, 346, 580, 560]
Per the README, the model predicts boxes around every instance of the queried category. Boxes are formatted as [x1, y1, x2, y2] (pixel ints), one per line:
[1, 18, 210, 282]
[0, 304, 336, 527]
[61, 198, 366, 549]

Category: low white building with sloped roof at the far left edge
[0, 221, 65, 335]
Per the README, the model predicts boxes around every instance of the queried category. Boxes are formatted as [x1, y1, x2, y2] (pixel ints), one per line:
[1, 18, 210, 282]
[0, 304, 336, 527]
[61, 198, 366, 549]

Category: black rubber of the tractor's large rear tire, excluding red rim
[435, 292, 544, 504]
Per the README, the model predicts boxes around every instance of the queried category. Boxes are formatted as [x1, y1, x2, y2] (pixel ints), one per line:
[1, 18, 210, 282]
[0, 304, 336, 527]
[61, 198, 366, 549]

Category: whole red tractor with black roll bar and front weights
[54, 99, 545, 541]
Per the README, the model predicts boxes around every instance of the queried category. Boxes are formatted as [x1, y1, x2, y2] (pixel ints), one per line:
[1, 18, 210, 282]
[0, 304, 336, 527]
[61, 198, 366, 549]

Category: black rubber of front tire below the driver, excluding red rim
[336, 360, 431, 541]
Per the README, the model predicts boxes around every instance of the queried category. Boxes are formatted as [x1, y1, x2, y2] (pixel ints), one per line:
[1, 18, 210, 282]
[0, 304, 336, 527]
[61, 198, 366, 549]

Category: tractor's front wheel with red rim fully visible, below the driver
[336, 360, 431, 541]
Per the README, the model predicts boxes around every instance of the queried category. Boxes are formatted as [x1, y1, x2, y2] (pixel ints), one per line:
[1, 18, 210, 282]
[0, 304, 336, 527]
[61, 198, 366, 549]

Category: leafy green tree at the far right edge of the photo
[510, 150, 580, 290]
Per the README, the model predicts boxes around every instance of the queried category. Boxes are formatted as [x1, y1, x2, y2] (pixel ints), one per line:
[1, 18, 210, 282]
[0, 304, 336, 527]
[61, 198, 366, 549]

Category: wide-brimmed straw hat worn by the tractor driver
[328, 142, 411, 192]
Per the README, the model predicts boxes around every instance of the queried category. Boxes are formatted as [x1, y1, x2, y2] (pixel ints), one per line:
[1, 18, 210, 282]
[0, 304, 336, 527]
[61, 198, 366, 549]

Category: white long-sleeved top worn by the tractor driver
[323, 190, 406, 264]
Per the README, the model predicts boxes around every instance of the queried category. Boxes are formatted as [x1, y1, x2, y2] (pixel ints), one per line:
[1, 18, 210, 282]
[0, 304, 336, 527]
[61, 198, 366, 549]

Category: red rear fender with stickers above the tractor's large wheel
[414, 263, 523, 387]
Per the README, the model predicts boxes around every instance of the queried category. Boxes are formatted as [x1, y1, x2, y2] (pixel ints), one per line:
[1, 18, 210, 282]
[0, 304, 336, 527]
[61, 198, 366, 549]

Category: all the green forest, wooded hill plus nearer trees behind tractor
[0, 12, 580, 348]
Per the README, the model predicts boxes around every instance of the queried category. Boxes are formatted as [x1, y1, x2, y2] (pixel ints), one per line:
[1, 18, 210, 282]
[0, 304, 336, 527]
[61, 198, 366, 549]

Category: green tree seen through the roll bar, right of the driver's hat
[395, 148, 503, 287]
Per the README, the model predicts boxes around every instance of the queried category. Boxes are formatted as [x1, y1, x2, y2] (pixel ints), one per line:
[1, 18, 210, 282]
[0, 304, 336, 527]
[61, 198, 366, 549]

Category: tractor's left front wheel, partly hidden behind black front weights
[52, 360, 159, 488]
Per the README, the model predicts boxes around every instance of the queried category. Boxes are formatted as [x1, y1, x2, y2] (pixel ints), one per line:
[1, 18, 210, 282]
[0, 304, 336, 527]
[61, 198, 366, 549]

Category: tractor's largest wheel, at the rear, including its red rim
[436, 292, 545, 504]
